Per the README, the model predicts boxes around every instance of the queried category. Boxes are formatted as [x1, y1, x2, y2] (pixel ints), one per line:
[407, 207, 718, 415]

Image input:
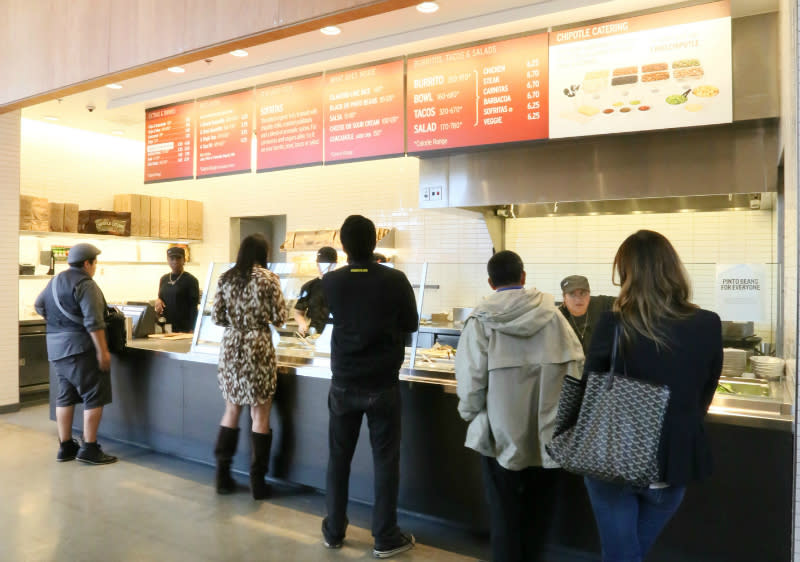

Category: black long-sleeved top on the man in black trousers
[322, 263, 419, 388]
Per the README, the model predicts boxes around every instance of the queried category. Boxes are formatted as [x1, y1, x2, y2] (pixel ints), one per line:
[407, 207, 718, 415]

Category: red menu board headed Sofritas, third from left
[256, 74, 322, 172]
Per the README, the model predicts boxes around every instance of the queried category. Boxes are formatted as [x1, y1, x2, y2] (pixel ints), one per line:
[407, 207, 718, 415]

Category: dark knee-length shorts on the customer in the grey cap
[53, 350, 111, 410]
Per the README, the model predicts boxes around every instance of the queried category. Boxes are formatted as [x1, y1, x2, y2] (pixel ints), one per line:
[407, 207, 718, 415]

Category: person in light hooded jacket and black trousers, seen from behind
[456, 251, 583, 562]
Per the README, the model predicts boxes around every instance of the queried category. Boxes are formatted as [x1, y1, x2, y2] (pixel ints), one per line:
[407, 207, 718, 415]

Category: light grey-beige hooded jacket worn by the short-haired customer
[456, 289, 584, 470]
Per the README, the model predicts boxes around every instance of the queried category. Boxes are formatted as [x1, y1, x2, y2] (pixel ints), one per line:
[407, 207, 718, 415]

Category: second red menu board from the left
[197, 88, 253, 178]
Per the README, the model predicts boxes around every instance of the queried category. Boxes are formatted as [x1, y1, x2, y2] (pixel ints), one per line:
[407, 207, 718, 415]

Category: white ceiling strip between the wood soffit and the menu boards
[22, 0, 778, 140]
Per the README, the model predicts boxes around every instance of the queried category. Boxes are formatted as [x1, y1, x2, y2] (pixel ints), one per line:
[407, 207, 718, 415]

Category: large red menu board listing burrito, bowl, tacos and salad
[406, 33, 548, 153]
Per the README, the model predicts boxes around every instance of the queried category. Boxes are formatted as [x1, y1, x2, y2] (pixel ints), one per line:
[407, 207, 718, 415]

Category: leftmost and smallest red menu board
[144, 101, 194, 183]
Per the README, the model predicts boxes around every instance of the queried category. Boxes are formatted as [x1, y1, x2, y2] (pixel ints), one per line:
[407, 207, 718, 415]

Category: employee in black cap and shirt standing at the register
[155, 247, 200, 332]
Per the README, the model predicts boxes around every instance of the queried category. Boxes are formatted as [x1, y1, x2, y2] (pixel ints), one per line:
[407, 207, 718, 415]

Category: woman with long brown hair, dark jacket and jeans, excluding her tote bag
[584, 230, 722, 562]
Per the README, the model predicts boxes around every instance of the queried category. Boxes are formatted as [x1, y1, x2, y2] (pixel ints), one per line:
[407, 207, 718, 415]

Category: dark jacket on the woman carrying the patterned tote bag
[584, 309, 722, 486]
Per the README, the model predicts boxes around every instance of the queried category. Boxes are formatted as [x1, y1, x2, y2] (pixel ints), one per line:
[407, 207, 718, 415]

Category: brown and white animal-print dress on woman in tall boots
[212, 266, 286, 405]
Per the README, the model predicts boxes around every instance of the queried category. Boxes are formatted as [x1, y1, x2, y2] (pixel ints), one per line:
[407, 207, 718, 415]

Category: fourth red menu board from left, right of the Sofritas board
[324, 59, 405, 162]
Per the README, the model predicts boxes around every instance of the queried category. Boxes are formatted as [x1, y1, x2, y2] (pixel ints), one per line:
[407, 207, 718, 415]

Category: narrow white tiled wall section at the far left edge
[0, 111, 20, 407]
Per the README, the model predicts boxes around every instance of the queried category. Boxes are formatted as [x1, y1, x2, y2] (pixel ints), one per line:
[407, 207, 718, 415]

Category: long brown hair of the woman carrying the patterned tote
[612, 230, 698, 348]
